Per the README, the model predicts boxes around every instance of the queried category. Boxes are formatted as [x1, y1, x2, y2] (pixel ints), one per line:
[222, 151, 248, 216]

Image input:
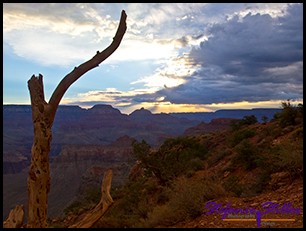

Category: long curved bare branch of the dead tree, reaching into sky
[49, 10, 127, 113]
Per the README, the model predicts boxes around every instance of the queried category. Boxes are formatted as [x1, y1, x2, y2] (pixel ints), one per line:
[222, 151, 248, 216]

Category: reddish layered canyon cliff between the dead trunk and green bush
[48, 136, 134, 216]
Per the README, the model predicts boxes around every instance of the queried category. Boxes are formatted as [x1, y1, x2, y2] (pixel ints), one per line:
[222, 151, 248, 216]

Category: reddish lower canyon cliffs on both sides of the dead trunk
[3, 136, 134, 219]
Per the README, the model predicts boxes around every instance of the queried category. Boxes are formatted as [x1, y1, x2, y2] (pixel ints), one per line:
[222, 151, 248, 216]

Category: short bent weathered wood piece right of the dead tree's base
[69, 169, 114, 228]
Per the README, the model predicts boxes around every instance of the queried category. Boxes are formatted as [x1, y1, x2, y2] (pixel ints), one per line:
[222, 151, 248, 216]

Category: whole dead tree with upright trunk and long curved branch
[27, 10, 127, 228]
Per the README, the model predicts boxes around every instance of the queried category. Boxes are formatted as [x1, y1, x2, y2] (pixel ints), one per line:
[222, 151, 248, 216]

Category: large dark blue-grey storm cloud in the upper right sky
[156, 4, 303, 104]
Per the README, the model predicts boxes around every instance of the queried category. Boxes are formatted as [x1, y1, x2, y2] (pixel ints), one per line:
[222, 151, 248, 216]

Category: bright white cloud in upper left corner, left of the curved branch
[3, 3, 123, 66]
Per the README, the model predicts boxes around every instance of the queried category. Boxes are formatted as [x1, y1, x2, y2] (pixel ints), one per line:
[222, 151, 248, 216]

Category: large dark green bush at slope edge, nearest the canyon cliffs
[134, 137, 208, 185]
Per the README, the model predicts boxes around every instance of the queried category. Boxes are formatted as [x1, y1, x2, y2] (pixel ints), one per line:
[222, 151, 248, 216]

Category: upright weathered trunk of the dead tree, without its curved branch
[28, 75, 53, 228]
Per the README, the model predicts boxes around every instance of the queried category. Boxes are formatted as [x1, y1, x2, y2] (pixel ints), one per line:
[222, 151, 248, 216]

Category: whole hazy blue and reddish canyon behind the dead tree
[3, 104, 279, 219]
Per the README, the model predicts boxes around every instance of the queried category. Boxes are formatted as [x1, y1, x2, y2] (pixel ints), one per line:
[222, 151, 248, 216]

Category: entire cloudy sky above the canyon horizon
[3, 3, 303, 114]
